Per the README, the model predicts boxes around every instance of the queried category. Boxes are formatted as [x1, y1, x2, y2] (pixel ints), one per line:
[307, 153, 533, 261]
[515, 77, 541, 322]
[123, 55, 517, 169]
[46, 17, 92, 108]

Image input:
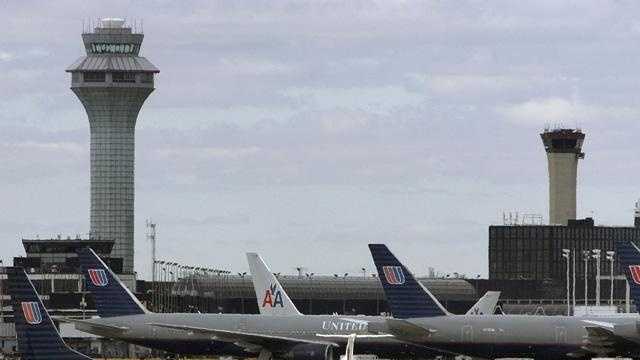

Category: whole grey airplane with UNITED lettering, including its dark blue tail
[71, 248, 450, 360]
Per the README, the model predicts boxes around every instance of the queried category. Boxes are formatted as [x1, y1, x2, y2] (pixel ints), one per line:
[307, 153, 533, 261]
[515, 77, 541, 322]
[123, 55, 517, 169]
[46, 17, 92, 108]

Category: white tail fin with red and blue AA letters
[247, 253, 302, 315]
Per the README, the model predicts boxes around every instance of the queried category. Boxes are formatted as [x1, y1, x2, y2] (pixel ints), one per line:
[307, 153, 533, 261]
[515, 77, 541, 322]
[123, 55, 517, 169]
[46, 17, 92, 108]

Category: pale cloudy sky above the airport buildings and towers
[0, 0, 640, 278]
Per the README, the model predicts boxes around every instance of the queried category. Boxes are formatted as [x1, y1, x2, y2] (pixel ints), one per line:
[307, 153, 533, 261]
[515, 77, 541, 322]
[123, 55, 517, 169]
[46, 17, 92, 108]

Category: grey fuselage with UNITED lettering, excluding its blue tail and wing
[76, 313, 442, 358]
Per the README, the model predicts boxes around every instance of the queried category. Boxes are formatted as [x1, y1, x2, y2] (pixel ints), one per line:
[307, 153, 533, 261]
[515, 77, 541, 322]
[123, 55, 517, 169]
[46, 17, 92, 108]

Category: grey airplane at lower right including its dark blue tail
[369, 244, 640, 360]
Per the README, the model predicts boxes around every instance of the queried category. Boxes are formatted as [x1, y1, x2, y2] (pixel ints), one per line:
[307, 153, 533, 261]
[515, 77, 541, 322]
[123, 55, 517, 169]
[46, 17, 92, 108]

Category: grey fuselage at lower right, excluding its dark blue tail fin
[402, 315, 640, 359]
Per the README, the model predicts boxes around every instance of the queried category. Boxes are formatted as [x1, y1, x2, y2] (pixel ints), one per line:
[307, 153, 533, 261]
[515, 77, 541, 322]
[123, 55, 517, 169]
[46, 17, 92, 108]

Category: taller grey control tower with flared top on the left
[67, 19, 160, 274]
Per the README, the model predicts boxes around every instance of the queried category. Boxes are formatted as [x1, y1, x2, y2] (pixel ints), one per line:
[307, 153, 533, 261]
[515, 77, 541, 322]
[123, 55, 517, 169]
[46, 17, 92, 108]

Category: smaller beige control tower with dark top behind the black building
[540, 129, 584, 225]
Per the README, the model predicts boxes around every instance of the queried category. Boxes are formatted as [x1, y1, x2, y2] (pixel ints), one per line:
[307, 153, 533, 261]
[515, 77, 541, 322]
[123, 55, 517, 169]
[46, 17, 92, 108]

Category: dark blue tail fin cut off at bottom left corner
[4, 267, 91, 360]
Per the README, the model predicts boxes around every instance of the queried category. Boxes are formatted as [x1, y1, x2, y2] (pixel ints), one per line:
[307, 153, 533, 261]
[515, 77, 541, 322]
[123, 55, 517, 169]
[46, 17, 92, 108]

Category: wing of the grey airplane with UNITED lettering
[147, 323, 339, 352]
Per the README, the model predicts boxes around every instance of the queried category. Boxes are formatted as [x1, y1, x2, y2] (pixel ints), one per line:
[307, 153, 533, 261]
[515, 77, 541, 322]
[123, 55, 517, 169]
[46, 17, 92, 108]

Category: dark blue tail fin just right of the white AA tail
[369, 244, 448, 319]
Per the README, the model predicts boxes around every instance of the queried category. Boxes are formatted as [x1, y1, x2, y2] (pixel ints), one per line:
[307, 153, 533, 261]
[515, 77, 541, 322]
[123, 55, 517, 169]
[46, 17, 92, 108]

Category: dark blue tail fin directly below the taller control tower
[78, 248, 148, 317]
